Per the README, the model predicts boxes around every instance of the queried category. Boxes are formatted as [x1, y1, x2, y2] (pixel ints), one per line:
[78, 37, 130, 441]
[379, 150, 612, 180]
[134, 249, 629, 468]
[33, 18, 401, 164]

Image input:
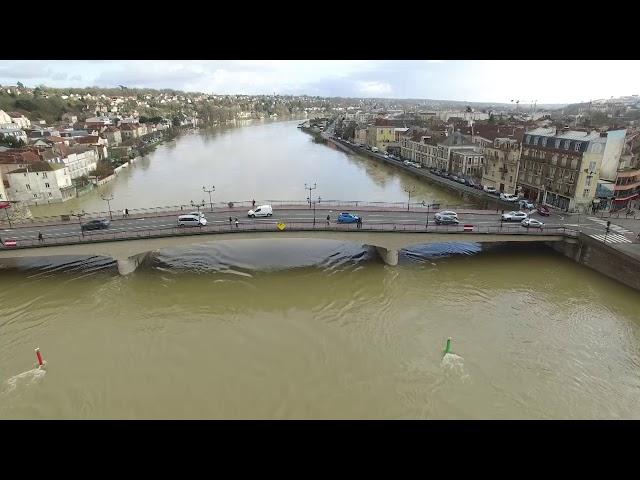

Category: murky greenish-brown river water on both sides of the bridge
[0, 122, 640, 419]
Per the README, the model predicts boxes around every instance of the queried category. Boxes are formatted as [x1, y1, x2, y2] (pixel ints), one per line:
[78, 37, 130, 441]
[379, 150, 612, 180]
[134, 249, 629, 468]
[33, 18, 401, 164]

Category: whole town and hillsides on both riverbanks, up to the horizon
[0, 83, 640, 219]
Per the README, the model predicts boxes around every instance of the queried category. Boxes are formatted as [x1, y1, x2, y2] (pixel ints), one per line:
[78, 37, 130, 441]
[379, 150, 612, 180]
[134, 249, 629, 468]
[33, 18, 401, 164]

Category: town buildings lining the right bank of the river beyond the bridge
[301, 95, 640, 213]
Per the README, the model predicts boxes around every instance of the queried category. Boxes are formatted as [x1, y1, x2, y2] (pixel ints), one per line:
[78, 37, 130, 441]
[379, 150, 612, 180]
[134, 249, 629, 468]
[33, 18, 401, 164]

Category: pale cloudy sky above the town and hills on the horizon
[0, 60, 640, 103]
